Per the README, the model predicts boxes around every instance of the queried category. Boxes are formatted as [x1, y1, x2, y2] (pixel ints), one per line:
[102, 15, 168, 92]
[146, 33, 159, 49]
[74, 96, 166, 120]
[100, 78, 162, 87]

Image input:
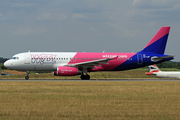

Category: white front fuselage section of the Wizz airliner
[5, 52, 76, 71]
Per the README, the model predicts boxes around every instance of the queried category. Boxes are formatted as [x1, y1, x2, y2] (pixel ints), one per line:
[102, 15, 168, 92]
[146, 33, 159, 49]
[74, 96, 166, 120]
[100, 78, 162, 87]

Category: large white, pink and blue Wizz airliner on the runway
[4, 26, 174, 80]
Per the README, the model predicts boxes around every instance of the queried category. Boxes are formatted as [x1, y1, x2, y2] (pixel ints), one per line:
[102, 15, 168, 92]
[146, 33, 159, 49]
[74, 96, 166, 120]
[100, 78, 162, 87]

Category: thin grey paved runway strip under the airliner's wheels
[0, 79, 180, 82]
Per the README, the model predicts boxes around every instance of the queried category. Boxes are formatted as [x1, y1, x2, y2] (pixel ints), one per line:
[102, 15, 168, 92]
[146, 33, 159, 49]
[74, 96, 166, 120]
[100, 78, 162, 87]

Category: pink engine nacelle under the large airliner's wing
[54, 66, 82, 76]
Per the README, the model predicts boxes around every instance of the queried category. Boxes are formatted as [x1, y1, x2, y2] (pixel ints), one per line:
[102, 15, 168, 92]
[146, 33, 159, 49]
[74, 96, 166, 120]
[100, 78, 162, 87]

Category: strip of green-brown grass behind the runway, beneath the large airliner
[0, 68, 178, 79]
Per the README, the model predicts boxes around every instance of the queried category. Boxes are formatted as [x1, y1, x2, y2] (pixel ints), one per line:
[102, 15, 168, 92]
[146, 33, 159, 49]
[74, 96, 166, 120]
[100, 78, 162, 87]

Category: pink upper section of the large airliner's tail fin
[145, 27, 170, 48]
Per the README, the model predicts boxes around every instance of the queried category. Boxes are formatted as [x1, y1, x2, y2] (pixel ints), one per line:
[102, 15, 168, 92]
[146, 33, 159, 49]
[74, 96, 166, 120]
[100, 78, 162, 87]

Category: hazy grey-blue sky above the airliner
[0, 0, 180, 62]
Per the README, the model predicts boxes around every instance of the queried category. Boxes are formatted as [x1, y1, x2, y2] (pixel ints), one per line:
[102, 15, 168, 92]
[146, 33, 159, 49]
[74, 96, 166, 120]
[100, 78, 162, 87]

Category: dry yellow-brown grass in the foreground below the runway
[0, 81, 180, 120]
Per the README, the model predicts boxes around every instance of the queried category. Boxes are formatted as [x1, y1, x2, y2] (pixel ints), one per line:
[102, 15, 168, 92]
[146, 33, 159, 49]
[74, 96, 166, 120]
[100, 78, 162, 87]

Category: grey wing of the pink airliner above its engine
[65, 56, 118, 69]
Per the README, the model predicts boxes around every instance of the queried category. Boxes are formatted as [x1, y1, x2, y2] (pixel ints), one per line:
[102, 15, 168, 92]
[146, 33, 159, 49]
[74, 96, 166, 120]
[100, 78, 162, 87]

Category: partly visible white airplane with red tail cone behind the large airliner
[146, 64, 180, 78]
